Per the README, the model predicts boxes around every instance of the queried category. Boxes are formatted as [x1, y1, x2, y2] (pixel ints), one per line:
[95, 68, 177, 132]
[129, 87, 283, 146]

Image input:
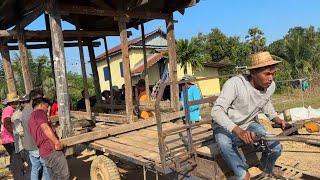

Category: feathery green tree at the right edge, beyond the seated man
[268, 26, 320, 78]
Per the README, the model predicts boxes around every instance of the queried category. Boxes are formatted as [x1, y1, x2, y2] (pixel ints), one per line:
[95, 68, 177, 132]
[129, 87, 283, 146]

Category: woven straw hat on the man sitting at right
[247, 51, 281, 70]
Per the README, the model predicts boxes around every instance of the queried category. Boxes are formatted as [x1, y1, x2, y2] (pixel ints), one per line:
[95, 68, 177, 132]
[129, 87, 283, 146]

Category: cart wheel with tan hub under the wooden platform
[90, 155, 120, 180]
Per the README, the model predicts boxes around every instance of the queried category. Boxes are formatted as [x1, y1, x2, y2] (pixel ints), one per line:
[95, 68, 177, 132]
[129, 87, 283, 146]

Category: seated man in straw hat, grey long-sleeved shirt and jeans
[211, 52, 286, 179]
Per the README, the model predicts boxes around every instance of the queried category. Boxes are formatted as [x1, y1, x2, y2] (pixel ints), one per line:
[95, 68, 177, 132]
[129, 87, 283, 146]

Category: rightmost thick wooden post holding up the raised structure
[166, 14, 179, 110]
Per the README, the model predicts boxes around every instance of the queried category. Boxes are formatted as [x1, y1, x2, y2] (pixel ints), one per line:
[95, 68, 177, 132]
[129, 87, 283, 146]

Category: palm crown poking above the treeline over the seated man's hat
[245, 27, 266, 53]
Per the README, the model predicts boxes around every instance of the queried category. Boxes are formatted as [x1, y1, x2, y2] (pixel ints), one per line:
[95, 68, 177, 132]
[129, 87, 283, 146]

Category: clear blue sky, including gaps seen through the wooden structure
[5, 0, 320, 74]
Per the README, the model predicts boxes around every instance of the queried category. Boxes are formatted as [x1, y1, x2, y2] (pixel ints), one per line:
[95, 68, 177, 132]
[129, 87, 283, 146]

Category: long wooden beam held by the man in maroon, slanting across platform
[61, 111, 184, 146]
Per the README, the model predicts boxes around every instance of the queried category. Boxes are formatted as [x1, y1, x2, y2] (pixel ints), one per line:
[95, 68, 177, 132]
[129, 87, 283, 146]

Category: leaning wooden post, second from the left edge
[17, 25, 33, 94]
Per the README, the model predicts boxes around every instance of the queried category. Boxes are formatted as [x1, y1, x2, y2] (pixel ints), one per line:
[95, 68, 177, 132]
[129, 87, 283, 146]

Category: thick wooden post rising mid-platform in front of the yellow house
[118, 16, 133, 122]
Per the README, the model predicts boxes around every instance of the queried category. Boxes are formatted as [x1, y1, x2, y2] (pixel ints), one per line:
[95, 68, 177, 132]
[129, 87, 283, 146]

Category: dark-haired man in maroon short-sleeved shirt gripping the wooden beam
[28, 98, 70, 180]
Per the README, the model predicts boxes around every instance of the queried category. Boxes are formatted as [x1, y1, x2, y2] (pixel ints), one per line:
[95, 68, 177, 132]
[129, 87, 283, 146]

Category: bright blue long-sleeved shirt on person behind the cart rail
[180, 85, 202, 122]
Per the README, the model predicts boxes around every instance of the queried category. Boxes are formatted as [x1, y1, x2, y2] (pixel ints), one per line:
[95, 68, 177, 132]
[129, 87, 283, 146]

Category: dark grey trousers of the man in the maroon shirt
[43, 151, 70, 180]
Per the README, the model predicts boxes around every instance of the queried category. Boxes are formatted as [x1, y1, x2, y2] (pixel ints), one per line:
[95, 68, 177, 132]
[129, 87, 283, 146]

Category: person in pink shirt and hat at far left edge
[1, 94, 19, 171]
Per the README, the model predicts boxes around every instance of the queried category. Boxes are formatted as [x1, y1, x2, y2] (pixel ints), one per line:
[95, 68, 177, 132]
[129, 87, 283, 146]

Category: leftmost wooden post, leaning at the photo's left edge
[0, 39, 17, 96]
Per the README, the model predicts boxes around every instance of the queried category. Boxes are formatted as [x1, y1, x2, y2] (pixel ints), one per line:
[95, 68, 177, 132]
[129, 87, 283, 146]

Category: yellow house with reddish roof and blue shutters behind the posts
[96, 29, 228, 96]
